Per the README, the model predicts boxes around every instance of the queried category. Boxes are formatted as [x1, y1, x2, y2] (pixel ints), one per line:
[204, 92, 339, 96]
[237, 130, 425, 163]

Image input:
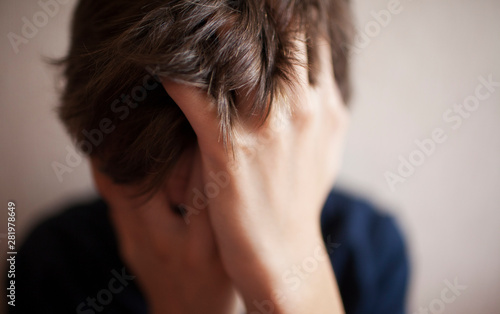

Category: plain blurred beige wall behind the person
[0, 0, 500, 313]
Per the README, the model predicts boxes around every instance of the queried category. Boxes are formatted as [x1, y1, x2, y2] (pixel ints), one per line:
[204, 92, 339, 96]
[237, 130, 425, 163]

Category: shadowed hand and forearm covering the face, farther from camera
[92, 146, 241, 314]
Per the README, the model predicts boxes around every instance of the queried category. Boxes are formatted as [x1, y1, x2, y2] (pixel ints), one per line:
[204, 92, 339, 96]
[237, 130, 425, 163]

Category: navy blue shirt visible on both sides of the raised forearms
[4, 191, 408, 314]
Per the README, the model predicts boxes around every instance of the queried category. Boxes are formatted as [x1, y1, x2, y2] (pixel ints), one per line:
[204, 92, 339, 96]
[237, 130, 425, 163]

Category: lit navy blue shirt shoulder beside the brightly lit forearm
[321, 191, 409, 313]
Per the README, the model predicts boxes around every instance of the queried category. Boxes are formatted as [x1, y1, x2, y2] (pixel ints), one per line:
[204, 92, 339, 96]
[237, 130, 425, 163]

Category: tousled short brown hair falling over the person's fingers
[59, 0, 352, 191]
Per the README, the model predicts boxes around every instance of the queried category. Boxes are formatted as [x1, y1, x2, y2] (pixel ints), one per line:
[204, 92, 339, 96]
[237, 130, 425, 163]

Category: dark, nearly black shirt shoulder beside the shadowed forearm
[11, 200, 146, 314]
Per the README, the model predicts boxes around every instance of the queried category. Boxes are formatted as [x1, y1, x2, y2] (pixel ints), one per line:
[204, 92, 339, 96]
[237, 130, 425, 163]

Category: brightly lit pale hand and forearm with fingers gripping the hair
[163, 37, 348, 313]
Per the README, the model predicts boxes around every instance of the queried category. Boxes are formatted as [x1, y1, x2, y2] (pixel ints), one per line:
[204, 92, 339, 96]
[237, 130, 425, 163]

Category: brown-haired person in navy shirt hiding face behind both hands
[9, 0, 408, 314]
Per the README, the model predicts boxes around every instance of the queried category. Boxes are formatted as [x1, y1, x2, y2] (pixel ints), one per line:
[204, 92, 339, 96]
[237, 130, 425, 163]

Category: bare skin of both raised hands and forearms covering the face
[92, 36, 349, 313]
